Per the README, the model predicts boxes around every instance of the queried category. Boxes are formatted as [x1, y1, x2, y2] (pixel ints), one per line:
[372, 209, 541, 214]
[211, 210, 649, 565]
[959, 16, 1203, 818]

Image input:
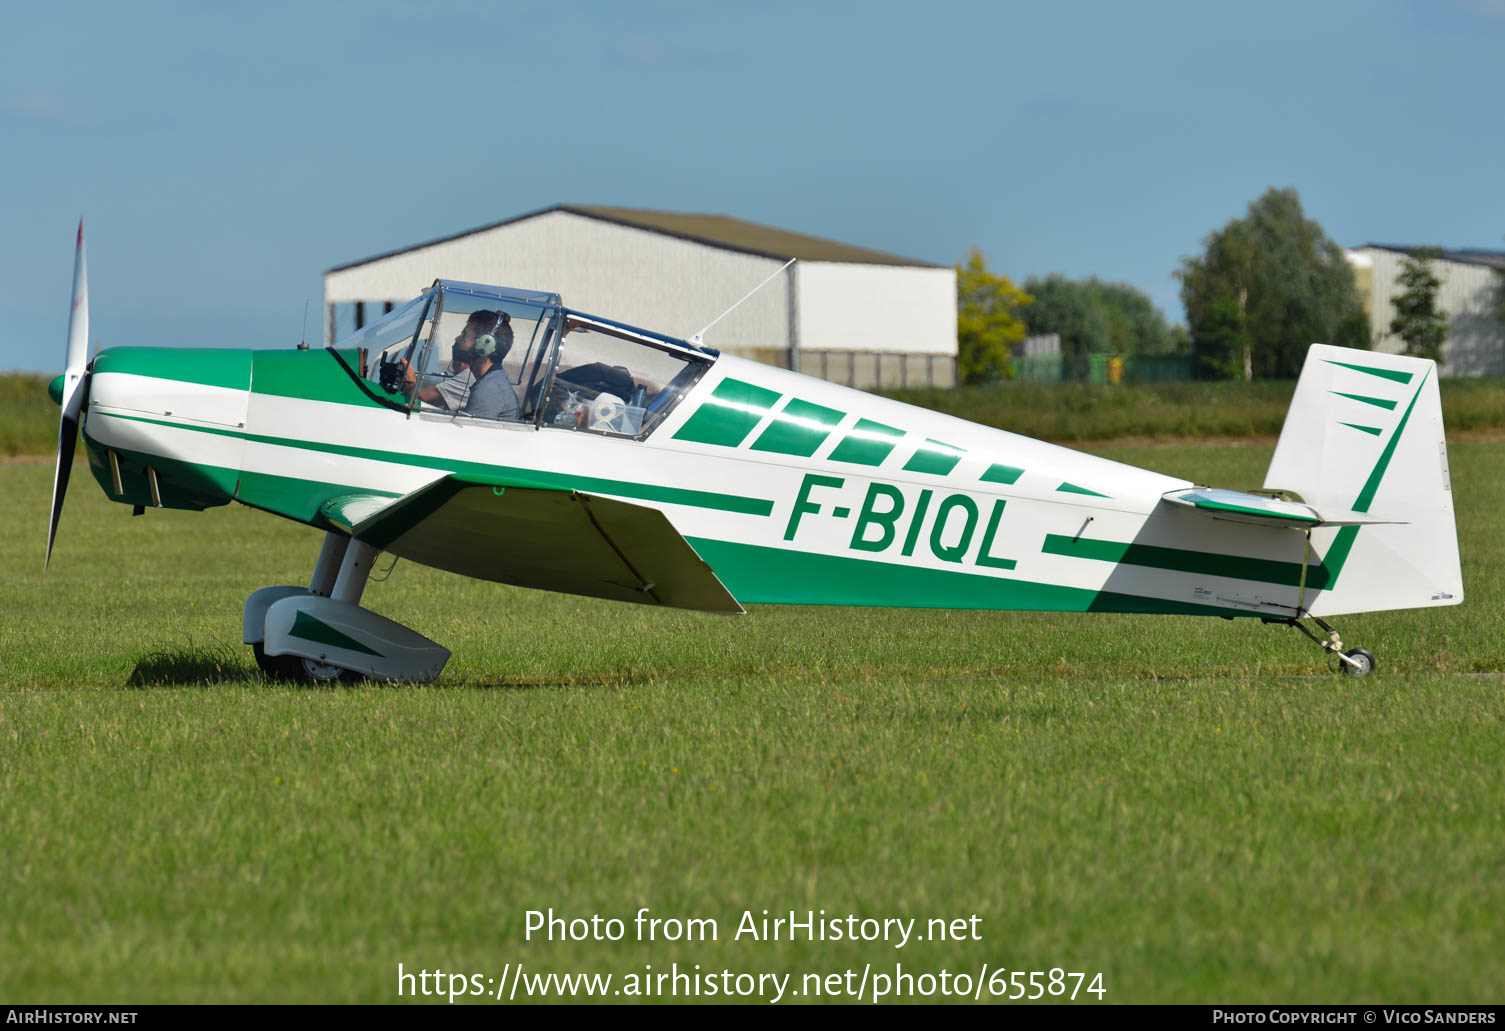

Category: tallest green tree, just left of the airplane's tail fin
[1175, 188, 1370, 379]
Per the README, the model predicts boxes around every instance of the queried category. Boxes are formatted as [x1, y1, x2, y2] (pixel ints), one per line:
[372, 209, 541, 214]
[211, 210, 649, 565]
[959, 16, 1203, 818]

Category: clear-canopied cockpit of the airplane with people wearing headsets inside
[344, 280, 716, 439]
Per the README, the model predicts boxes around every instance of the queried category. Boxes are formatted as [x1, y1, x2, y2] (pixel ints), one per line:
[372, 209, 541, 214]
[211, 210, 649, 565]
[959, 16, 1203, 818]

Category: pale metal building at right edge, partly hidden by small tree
[1348, 244, 1505, 376]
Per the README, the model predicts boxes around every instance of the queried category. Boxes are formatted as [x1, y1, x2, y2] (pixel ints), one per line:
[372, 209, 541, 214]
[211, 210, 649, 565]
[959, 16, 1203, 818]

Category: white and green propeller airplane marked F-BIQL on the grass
[47, 226, 1463, 682]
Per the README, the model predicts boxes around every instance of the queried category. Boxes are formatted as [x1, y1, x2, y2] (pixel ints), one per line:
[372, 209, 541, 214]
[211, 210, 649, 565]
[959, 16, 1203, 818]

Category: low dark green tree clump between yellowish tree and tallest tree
[1025, 274, 1172, 361]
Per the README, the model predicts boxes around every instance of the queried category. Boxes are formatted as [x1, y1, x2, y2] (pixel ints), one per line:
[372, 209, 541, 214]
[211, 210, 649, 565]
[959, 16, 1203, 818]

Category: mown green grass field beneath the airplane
[0, 443, 1505, 1002]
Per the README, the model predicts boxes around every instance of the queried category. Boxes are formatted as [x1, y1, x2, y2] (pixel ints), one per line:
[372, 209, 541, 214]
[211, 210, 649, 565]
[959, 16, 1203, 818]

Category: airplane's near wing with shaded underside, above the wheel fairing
[324, 476, 742, 613]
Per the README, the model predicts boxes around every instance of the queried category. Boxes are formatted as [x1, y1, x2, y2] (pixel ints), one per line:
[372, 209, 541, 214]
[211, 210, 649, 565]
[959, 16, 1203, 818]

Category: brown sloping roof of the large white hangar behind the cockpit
[330, 205, 944, 272]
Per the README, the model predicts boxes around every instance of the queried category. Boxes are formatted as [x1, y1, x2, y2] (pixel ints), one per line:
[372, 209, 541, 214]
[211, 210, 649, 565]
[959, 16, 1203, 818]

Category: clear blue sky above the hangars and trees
[0, 0, 1505, 372]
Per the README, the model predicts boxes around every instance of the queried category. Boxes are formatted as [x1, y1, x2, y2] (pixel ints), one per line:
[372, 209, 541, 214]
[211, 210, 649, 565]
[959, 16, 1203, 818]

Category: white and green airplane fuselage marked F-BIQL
[84, 337, 1305, 616]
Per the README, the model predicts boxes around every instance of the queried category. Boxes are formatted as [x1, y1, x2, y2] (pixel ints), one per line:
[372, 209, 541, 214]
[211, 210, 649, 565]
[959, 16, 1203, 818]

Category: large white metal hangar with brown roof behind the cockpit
[324, 205, 957, 388]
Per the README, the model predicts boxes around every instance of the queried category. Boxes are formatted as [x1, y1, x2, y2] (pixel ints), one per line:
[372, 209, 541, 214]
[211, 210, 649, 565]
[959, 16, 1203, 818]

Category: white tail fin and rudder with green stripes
[1264, 343, 1463, 616]
